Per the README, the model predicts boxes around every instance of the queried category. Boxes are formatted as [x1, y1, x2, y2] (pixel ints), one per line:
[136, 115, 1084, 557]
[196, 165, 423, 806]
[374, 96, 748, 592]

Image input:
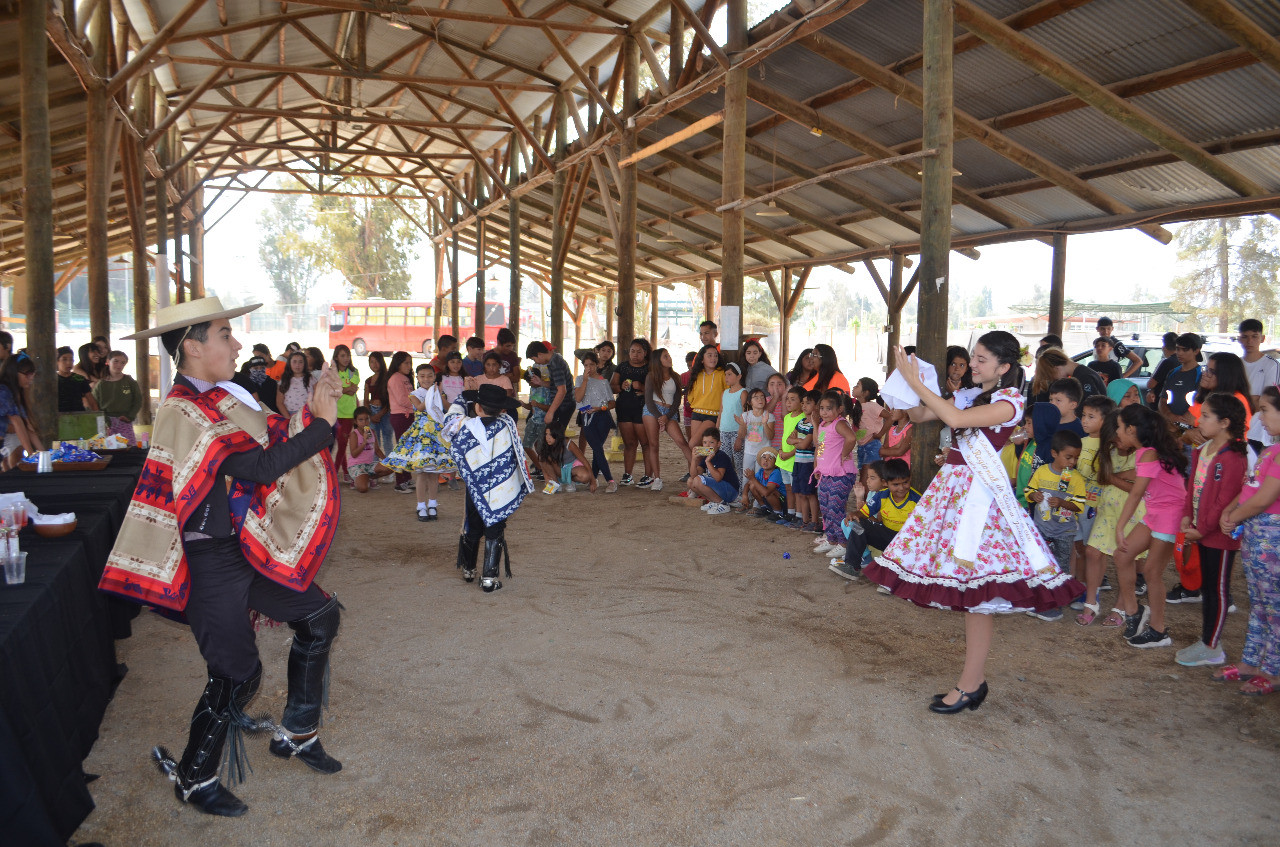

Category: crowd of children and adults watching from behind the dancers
[272, 321, 1280, 710]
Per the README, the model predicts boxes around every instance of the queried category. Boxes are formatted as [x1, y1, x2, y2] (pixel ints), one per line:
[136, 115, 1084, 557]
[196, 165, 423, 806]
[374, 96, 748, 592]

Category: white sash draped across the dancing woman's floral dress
[954, 430, 1057, 573]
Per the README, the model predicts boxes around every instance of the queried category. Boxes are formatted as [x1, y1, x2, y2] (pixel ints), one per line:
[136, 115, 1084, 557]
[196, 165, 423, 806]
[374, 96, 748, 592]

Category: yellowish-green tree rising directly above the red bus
[315, 179, 417, 299]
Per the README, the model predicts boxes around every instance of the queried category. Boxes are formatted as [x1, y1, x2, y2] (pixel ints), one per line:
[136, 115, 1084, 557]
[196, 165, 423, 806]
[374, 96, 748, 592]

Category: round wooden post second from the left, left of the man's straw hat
[84, 3, 111, 345]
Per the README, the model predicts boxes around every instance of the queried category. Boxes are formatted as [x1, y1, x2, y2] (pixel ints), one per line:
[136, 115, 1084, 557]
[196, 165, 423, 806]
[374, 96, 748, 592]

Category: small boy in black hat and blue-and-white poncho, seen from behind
[440, 385, 534, 592]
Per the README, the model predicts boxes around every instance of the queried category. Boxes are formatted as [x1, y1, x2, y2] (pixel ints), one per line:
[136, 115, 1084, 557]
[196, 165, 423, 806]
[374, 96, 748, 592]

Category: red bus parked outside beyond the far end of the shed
[329, 299, 507, 356]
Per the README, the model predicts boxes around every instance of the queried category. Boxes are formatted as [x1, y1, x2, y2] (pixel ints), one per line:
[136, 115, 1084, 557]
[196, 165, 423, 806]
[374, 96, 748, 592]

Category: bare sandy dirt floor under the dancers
[73, 443, 1280, 847]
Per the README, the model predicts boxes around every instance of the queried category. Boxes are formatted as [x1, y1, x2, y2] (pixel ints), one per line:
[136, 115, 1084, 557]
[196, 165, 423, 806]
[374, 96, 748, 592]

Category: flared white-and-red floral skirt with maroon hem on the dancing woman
[863, 464, 1084, 614]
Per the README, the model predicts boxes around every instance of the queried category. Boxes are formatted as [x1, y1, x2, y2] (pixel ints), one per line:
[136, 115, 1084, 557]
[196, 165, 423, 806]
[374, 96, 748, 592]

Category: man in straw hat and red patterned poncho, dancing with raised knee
[100, 297, 342, 818]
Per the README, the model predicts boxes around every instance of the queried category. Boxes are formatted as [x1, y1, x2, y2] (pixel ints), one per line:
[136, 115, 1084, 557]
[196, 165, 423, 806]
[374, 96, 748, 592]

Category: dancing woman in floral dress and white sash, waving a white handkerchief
[863, 330, 1083, 714]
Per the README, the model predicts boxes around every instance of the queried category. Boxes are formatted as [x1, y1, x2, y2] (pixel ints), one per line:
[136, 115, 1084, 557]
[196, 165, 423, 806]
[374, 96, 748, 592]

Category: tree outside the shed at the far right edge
[1171, 216, 1280, 333]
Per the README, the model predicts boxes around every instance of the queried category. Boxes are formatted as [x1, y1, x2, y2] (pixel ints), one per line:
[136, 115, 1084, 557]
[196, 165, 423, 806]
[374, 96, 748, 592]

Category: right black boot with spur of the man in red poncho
[269, 596, 342, 774]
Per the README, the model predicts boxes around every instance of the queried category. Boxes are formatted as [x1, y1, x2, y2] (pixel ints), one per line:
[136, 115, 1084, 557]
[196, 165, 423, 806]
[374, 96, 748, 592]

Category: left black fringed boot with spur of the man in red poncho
[151, 665, 262, 818]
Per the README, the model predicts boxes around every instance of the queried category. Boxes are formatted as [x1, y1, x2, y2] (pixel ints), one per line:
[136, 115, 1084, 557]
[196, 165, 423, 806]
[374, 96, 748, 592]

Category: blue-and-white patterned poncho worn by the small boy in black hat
[440, 397, 534, 526]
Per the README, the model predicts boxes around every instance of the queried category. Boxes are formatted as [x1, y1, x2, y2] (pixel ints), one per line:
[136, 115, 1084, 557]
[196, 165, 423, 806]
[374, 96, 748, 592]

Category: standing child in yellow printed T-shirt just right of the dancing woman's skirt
[1025, 432, 1088, 621]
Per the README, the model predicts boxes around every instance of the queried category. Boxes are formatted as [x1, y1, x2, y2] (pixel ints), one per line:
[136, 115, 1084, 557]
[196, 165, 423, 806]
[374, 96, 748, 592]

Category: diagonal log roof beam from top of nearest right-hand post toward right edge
[955, 0, 1266, 197]
